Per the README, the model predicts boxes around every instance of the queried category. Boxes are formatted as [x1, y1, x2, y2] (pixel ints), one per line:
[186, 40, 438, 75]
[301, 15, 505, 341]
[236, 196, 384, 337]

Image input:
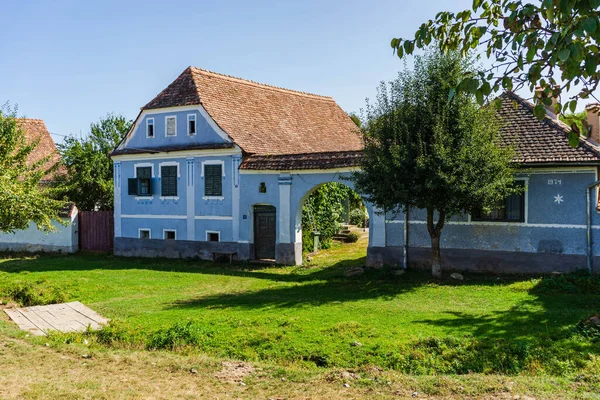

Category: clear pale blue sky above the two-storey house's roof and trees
[0, 0, 482, 141]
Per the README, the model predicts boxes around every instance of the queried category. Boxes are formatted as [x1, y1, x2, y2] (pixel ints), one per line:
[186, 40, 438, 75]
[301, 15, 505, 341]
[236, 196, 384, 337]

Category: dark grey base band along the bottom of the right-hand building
[379, 246, 600, 274]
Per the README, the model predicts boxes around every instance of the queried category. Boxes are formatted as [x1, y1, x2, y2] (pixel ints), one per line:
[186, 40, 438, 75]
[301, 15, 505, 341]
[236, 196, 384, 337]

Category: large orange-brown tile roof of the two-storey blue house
[142, 67, 363, 156]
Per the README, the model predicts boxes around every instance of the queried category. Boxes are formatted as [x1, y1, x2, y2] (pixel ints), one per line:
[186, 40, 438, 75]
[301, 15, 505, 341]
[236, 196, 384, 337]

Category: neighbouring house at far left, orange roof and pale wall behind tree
[0, 118, 78, 253]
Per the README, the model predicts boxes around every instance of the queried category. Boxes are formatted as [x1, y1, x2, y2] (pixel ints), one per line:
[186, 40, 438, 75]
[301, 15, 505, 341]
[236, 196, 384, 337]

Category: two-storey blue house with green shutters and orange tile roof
[112, 67, 385, 264]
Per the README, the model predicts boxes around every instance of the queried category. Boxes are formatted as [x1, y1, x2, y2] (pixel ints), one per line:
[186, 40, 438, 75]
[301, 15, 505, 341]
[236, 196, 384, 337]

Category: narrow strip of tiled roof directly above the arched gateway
[240, 151, 363, 171]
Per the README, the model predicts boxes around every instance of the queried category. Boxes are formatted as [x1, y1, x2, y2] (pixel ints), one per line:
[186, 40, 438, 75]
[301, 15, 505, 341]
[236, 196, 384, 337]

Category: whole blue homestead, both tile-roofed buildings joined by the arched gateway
[112, 67, 600, 272]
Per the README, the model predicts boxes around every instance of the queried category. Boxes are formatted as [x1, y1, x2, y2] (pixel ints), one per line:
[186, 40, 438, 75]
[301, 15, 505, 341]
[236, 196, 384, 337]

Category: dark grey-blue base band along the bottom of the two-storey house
[114, 237, 254, 260]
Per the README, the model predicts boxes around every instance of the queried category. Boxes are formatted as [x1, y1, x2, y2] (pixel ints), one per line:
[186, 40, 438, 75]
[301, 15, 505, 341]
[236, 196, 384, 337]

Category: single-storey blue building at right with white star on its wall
[380, 93, 600, 273]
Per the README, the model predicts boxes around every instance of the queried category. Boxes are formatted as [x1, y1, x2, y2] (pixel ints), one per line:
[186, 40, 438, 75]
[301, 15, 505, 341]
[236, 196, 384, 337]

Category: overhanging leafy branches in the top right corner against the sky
[391, 0, 600, 130]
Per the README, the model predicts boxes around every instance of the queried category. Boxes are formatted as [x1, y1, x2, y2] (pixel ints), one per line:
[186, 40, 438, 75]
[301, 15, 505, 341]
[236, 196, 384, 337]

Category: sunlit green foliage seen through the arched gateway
[302, 182, 362, 252]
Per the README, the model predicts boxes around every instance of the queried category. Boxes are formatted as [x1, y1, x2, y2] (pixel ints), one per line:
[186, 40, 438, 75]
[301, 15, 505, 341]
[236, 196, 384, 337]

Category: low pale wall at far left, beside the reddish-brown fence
[0, 209, 79, 253]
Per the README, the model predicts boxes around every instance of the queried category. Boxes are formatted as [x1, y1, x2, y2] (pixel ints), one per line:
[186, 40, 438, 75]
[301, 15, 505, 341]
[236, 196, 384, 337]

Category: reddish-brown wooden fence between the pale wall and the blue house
[79, 211, 115, 252]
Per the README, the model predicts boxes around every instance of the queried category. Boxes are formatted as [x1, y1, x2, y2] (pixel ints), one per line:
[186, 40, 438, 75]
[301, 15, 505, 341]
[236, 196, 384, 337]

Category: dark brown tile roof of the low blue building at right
[498, 92, 600, 165]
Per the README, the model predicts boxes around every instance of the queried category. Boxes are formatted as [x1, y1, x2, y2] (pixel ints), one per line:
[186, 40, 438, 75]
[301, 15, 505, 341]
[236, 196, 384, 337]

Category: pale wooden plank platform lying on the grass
[4, 301, 109, 336]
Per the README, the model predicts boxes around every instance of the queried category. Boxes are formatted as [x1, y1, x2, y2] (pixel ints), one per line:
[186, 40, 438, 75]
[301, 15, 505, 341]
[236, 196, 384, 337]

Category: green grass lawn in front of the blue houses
[0, 239, 600, 378]
